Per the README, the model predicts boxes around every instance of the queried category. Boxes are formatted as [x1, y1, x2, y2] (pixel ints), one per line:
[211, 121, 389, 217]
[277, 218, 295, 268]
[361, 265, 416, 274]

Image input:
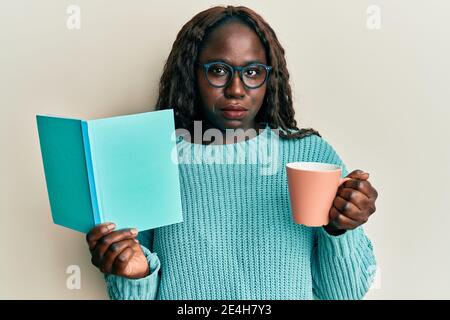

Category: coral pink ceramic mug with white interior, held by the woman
[286, 162, 350, 227]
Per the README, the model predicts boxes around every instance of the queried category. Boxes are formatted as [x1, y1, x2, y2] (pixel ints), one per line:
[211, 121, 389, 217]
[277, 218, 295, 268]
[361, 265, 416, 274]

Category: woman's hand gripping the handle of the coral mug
[324, 170, 378, 235]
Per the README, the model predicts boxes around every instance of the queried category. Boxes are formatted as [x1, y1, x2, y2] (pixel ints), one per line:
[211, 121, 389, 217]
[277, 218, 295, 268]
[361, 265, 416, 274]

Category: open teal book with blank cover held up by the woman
[36, 109, 183, 233]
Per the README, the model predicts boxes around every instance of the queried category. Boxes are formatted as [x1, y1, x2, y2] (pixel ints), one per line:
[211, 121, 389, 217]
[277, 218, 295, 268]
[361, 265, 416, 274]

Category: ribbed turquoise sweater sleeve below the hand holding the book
[105, 231, 161, 300]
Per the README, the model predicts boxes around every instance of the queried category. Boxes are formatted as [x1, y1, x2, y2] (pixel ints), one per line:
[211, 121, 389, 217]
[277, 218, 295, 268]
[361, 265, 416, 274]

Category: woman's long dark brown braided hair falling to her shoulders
[156, 6, 320, 139]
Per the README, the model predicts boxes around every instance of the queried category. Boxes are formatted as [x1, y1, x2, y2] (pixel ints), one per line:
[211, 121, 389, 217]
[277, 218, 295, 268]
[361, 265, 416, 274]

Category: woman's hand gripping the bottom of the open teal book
[86, 222, 150, 279]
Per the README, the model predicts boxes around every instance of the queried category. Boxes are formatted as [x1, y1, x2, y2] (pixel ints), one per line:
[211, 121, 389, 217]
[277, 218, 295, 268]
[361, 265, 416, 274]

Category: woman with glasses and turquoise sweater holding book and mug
[87, 6, 377, 299]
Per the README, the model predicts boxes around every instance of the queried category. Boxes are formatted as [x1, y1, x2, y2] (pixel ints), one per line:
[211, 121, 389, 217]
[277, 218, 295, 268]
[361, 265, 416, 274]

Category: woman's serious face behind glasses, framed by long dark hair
[197, 22, 267, 130]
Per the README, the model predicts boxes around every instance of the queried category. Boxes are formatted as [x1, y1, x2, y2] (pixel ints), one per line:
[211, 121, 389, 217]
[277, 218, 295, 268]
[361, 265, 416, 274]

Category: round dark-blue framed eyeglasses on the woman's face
[203, 62, 272, 89]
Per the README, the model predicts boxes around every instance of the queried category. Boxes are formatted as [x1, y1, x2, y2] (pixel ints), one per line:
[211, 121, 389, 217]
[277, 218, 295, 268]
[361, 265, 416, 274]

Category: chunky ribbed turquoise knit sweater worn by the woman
[105, 127, 376, 299]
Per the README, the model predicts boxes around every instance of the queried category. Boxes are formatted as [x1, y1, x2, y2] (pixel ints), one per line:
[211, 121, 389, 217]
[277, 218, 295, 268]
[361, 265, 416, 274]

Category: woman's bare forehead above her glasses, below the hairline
[199, 21, 267, 66]
